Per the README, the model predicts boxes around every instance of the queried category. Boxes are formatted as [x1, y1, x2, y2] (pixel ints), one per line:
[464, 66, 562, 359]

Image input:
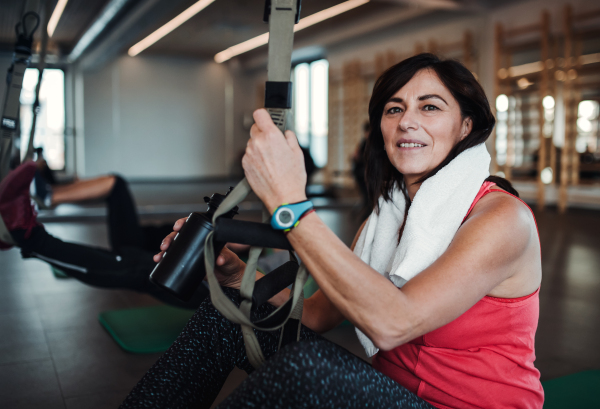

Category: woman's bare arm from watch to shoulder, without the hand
[288, 191, 539, 350]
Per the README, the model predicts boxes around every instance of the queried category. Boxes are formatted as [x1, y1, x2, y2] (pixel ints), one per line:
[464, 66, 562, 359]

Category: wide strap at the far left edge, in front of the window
[0, 11, 40, 180]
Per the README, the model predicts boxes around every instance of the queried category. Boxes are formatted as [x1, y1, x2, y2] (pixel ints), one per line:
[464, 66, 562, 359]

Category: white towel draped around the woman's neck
[354, 143, 491, 356]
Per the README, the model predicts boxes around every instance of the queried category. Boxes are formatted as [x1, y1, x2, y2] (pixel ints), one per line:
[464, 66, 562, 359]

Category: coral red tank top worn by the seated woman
[373, 182, 544, 409]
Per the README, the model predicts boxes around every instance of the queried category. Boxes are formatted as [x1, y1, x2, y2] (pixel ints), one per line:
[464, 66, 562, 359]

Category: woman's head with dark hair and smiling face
[366, 54, 506, 207]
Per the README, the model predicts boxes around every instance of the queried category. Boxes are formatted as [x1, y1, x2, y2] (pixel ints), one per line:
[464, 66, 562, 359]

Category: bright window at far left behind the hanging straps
[20, 68, 65, 170]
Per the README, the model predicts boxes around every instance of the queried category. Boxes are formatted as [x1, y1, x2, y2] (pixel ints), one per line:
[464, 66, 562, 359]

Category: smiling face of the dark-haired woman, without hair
[381, 69, 472, 184]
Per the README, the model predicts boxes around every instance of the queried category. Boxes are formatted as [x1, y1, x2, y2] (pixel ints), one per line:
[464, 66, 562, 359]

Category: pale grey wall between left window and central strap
[83, 56, 232, 179]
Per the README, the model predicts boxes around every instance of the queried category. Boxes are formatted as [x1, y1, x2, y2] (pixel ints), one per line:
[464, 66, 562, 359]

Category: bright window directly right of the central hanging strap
[293, 60, 329, 168]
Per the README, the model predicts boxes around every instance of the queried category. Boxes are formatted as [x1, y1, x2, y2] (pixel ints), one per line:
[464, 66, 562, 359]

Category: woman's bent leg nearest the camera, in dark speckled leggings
[218, 339, 433, 409]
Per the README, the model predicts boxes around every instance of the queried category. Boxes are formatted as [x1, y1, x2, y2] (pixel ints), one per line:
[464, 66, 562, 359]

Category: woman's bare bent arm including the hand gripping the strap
[242, 110, 539, 350]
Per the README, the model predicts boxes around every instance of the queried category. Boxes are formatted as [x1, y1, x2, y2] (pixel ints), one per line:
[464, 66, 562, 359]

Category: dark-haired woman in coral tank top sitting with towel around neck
[121, 54, 543, 408]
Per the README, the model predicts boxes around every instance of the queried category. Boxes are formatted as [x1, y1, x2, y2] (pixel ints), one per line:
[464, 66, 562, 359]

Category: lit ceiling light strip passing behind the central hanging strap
[215, 0, 369, 63]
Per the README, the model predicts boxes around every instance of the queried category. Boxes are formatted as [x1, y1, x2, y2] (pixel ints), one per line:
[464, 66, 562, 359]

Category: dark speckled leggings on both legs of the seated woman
[120, 288, 432, 409]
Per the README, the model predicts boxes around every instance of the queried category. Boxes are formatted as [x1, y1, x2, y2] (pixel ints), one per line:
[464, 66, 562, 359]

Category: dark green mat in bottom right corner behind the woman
[542, 370, 600, 409]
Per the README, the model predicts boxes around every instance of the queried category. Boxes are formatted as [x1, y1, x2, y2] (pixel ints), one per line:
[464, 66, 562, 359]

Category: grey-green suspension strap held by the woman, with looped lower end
[204, 0, 308, 368]
